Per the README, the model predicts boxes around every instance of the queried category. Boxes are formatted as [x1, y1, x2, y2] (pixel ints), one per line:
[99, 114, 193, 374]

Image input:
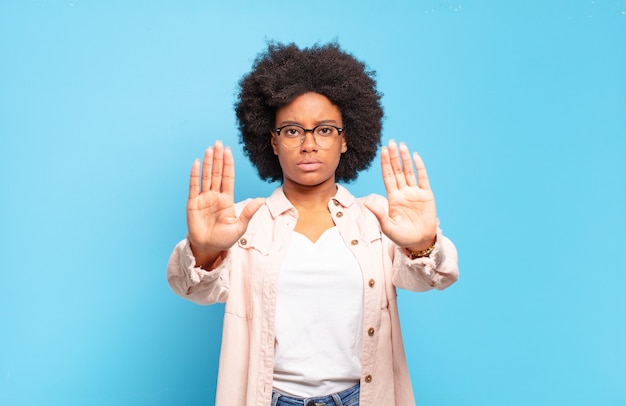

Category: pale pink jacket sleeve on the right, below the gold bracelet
[391, 228, 459, 292]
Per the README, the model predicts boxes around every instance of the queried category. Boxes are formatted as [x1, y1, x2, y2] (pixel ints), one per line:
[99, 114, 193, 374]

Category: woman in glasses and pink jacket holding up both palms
[167, 44, 458, 406]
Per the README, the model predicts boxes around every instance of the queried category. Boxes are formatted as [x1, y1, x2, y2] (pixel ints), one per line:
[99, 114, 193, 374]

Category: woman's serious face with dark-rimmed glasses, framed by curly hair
[271, 93, 347, 186]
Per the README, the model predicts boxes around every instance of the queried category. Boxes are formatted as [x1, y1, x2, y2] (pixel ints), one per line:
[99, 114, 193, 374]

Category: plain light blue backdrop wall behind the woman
[0, 0, 626, 406]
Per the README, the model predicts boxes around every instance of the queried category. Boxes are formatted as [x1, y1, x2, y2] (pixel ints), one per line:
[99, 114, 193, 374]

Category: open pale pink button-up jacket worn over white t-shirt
[167, 186, 458, 406]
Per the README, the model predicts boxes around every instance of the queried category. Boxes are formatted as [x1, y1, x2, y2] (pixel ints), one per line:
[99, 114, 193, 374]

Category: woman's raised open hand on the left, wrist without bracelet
[187, 141, 265, 268]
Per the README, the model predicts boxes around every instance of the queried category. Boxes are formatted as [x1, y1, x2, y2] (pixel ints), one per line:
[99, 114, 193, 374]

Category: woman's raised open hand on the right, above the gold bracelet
[365, 140, 437, 251]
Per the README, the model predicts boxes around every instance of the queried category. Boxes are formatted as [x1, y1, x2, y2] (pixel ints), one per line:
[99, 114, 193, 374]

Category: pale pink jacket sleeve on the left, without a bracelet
[167, 238, 231, 304]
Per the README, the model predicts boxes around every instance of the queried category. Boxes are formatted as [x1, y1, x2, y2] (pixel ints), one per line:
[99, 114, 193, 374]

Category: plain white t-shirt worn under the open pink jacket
[274, 227, 363, 397]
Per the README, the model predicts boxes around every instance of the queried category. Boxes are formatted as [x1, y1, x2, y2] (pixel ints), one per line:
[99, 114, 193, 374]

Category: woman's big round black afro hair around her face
[235, 42, 383, 182]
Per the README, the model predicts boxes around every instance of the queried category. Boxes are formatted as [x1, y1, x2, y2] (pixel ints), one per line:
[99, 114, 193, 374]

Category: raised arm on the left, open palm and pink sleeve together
[167, 141, 264, 304]
